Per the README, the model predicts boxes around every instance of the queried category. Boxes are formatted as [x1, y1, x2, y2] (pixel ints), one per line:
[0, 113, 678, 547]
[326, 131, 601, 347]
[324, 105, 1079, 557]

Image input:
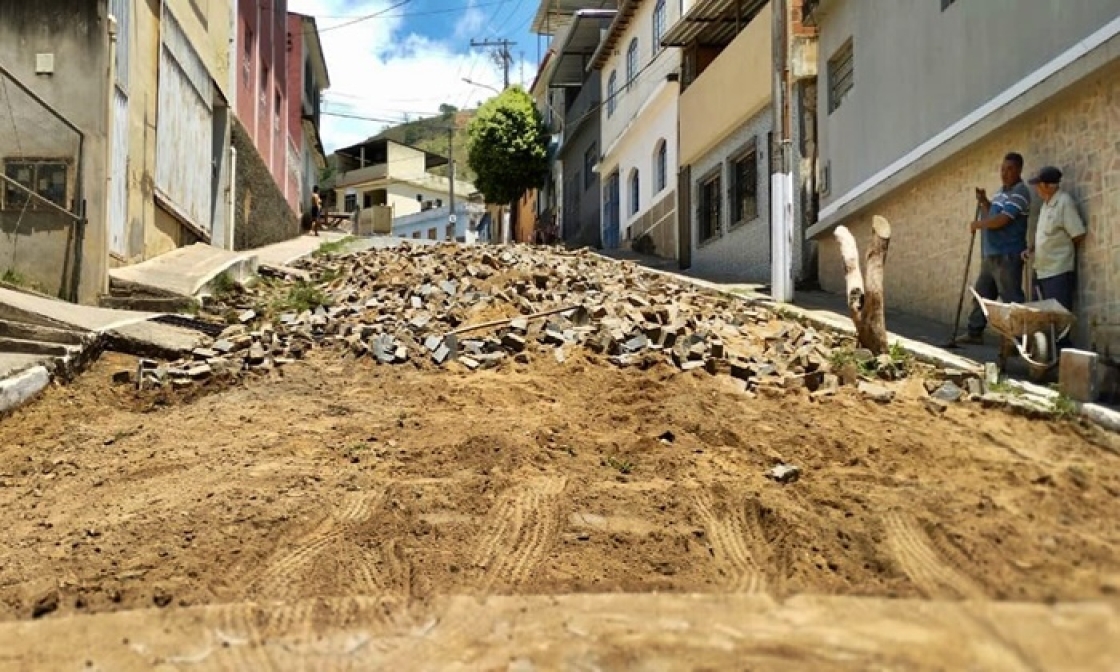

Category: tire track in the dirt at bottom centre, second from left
[474, 476, 568, 592]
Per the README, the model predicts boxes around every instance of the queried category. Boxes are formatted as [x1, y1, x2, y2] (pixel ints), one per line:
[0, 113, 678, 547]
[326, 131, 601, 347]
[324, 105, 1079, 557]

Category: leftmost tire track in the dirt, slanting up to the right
[249, 492, 384, 600]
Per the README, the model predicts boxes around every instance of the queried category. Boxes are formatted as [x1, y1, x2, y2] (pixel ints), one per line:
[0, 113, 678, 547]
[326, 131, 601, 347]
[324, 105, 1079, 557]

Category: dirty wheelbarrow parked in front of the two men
[971, 289, 1076, 382]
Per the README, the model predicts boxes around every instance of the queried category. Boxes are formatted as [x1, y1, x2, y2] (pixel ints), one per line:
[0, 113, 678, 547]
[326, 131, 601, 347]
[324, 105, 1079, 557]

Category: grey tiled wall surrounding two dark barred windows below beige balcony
[690, 109, 773, 282]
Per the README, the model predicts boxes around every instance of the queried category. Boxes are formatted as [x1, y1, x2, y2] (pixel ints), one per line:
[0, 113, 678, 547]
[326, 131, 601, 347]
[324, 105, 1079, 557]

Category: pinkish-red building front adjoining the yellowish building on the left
[236, 0, 300, 213]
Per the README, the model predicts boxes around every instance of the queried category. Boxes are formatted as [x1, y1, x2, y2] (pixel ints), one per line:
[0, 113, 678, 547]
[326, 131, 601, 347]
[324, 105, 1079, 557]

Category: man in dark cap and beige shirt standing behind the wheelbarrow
[1023, 166, 1085, 347]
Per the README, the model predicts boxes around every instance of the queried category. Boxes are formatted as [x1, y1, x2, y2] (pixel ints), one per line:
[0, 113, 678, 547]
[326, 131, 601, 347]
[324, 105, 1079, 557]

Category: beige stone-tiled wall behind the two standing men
[819, 64, 1120, 356]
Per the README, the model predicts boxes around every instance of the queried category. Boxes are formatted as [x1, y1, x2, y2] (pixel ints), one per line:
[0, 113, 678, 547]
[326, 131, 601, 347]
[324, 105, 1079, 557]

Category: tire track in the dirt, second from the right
[693, 493, 766, 592]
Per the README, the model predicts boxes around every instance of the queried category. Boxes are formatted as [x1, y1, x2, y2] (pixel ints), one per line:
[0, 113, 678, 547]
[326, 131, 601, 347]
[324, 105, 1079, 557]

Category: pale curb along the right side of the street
[592, 252, 1120, 433]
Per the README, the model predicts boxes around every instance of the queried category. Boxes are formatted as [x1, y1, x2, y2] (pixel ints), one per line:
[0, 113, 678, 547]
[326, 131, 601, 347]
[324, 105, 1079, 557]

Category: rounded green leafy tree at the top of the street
[467, 86, 549, 204]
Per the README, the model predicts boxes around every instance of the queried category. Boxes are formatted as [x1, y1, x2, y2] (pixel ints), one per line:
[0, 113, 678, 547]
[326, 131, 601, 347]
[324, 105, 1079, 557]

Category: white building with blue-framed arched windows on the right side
[591, 0, 681, 258]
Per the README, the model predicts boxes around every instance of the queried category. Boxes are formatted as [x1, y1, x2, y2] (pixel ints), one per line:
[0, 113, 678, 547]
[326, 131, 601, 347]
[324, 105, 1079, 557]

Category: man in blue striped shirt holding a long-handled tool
[965, 151, 1030, 344]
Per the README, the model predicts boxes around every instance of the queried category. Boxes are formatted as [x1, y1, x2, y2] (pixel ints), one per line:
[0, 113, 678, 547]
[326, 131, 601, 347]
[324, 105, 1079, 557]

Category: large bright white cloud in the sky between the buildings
[288, 0, 535, 151]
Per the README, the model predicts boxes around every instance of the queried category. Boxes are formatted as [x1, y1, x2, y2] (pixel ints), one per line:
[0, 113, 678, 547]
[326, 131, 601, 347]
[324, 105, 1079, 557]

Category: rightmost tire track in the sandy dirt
[884, 512, 987, 599]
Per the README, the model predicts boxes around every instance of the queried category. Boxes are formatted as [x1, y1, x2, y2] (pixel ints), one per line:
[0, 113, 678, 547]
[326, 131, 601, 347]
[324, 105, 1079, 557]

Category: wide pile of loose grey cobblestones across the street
[127, 245, 931, 401]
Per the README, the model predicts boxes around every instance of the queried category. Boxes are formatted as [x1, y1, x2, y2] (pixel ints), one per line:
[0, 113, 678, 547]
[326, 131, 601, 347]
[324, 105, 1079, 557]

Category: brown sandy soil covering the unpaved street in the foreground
[0, 352, 1120, 619]
